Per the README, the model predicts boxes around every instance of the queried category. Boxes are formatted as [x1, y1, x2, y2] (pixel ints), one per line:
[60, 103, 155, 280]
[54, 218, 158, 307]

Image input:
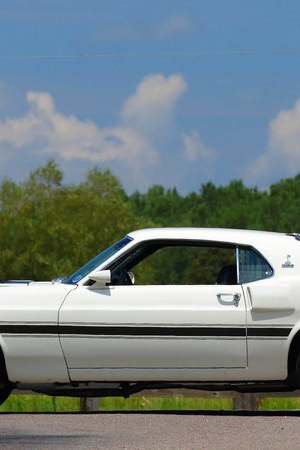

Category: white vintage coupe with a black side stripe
[0, 228, 300, 402]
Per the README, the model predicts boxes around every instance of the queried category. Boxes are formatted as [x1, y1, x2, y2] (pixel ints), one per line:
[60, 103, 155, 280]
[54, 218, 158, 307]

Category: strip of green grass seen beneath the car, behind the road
[0, 395, 300, 413]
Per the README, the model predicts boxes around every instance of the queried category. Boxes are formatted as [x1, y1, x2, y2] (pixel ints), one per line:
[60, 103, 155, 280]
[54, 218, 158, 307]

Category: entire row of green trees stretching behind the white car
[0, 160, 300, 280]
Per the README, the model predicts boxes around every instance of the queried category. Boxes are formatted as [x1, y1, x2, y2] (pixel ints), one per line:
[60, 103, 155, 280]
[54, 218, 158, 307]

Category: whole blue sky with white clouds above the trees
[0, 0, 300, 195]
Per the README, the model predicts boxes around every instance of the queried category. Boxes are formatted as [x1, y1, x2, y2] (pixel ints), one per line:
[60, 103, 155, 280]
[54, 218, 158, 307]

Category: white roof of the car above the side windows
[128, 227, 298, 246]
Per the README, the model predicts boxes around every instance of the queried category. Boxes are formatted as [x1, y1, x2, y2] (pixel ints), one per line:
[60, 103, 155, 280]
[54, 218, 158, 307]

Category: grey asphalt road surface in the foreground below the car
[0, 412, 300, 450]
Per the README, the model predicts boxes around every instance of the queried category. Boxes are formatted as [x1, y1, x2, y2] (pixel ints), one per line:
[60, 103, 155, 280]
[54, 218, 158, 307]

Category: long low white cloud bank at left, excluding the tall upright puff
[0, 92, 155, 167]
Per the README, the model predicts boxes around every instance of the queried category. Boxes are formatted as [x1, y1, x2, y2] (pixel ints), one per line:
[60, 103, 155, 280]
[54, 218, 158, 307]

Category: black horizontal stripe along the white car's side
[0, 324, 291, 337]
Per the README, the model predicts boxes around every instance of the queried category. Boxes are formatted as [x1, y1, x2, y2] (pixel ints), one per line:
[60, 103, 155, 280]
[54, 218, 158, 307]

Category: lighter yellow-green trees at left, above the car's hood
[0, 160, 149, 280]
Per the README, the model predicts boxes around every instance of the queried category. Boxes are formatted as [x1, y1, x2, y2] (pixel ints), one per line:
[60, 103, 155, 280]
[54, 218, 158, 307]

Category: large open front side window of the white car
[111, 241, 237, 285]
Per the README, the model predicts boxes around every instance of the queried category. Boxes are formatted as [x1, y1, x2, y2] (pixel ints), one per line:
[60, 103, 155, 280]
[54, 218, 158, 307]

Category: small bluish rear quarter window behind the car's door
[238, 248, 273, 284]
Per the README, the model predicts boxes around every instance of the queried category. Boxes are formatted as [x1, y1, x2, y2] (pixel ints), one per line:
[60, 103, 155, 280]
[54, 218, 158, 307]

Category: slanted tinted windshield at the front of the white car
[63, 236, 132, 284]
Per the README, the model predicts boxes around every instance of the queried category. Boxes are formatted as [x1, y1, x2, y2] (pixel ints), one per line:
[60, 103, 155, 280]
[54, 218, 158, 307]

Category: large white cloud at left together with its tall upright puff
[0, 74, 187, 169]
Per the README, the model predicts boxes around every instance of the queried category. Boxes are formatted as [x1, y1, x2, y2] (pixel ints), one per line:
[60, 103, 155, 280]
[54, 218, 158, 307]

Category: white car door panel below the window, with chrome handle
[59, 285, 247, 381]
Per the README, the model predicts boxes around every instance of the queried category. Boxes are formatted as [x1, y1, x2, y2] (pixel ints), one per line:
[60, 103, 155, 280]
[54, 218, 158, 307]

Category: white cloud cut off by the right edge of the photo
[248, 99, 300, 180]
